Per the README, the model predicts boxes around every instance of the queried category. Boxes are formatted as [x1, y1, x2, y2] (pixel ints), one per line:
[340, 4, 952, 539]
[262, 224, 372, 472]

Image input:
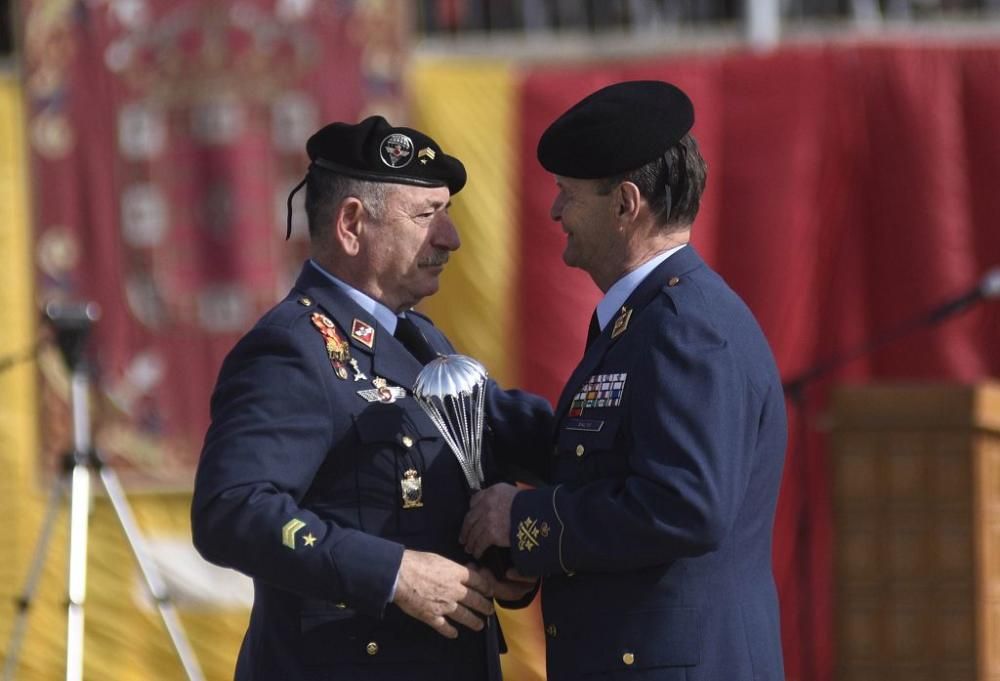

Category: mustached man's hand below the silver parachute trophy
[392, 549, 493, 638]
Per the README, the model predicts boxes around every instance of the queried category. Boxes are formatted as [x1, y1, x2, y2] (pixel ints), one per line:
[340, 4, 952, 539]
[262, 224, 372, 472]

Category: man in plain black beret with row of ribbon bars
[463, 81, 786, 681]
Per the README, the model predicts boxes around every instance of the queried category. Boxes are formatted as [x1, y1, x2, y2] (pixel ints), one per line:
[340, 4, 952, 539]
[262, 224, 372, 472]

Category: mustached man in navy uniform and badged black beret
[192, 116, 551, 681]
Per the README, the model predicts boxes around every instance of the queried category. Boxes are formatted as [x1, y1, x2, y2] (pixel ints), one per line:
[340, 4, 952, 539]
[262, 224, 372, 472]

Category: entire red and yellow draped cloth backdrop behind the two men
[0, 5, 1000, 681]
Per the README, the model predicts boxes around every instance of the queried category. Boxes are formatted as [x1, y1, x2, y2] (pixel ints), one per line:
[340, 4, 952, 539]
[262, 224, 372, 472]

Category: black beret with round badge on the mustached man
[306, 116, 466, 194]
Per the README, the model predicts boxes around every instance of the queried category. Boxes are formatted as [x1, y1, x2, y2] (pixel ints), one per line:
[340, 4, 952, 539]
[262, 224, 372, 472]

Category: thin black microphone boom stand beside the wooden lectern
[782, 268, 1000, 679]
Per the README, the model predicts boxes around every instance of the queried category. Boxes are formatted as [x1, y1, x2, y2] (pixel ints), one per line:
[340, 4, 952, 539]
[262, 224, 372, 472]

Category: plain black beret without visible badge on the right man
[538, 80, 694, 179]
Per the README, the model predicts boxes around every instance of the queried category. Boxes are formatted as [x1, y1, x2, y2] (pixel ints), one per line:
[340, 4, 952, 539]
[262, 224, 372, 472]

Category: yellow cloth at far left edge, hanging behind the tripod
[0, 74, 247, 681]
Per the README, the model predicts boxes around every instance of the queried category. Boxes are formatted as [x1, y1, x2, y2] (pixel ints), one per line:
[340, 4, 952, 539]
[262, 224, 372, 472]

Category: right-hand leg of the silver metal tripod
[95, 454, 205, 681]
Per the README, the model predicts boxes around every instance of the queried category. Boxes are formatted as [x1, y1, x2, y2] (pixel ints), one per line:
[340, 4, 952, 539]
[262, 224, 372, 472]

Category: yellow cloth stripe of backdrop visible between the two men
[407, 59, 545, 681]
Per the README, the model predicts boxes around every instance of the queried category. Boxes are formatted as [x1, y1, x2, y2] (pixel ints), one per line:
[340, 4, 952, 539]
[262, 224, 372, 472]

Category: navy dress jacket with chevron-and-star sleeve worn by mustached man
[192, 263, 551, 681]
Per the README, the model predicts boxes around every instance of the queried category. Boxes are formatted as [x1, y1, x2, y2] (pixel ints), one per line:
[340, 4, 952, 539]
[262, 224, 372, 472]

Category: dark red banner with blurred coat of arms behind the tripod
[24, 0, 407, 486]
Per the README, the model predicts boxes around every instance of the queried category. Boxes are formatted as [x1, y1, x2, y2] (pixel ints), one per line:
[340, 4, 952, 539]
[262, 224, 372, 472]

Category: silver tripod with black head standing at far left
[2, 303, 204, 681]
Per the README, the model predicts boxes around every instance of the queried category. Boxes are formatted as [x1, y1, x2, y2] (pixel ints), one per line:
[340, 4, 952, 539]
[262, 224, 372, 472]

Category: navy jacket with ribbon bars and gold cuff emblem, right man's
[511, 246, 787, 681]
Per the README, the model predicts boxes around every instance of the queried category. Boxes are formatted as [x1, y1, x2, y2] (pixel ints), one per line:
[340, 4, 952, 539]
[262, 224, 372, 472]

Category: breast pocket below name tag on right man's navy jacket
[555, 418, 628, 482]
